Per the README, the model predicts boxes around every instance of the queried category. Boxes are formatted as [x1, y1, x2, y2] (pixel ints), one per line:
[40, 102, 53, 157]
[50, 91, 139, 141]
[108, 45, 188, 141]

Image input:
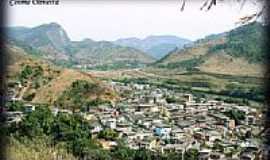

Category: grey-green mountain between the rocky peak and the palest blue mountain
[69, 39, 154, 67]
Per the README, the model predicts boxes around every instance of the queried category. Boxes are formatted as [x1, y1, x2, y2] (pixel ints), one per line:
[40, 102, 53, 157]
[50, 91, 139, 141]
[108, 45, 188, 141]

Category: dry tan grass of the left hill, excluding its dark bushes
[8, 46, 116, 104]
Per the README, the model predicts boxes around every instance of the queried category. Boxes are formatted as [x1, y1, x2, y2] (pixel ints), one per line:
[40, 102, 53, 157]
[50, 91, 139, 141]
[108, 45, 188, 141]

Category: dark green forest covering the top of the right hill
[209, 22, 267, 63]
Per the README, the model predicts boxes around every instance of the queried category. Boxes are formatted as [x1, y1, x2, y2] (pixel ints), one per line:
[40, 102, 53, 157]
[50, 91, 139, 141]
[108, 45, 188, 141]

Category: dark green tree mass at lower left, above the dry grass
[9, 107, 100, 156]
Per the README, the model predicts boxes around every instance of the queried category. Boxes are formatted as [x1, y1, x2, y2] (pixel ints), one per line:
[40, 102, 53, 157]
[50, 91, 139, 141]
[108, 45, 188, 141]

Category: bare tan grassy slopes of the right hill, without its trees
[156, 40, 264, 77]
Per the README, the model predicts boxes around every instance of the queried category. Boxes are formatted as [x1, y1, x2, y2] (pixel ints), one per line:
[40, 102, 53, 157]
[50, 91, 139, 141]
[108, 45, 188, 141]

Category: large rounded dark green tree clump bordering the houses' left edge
[50, 114, 99, 157]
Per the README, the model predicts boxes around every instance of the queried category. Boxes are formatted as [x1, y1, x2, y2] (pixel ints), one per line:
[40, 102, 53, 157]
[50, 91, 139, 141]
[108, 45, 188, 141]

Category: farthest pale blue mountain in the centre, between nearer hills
[114, 36, 191, 59]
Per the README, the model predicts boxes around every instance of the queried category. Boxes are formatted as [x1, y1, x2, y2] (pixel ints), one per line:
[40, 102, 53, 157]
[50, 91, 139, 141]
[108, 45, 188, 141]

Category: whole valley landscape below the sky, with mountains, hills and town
[4, 22, 266, 160]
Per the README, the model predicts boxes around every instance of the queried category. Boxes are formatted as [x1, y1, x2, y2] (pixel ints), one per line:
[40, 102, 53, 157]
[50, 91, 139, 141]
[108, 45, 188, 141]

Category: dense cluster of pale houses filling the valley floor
[4, 82, 268, 160]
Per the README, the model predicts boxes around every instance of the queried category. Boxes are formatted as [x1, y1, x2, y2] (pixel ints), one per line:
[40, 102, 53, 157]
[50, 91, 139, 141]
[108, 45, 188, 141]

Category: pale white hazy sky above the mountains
[7, 0, 259, 40]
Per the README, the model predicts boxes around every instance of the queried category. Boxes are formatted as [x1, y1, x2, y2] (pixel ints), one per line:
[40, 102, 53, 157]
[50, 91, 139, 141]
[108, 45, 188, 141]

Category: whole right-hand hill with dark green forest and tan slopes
[154, 22, 267, 75]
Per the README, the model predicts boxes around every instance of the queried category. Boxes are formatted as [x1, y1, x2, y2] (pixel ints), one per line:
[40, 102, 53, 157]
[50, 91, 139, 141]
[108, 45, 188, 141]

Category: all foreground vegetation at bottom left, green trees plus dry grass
[7, 107, 193, 160]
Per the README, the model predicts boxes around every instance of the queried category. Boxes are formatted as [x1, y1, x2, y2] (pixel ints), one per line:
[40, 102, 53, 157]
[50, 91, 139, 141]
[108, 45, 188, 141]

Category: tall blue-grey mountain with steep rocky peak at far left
[8, 23, 70, 60]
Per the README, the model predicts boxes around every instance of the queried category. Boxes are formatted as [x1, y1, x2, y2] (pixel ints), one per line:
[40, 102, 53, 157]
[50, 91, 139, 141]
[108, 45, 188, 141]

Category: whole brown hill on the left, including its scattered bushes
[7, 45, 117, 108]
